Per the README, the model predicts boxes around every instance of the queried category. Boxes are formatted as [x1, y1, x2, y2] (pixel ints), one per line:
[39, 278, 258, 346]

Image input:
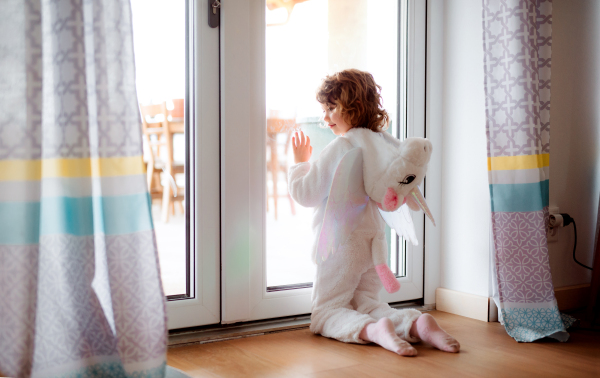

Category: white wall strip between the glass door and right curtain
[440, 0, 490, 296]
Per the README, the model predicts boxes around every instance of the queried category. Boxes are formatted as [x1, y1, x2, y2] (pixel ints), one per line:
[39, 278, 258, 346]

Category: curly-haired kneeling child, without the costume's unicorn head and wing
[288, 69, 460, 356]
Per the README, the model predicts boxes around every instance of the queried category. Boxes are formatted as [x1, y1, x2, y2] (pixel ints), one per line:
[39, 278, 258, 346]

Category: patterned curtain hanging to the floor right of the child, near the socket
[483, 0, 572, 341]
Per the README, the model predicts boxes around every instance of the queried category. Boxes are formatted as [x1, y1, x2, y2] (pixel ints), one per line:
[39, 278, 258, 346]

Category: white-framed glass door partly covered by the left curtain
[131, 0, 221, 328]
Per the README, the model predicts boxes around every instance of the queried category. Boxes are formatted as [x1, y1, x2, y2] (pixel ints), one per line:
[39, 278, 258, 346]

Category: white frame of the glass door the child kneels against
[220, 0, 426, 323]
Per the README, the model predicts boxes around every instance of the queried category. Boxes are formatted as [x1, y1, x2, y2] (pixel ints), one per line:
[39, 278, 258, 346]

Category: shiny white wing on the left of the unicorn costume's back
[317, 148, 369, 264]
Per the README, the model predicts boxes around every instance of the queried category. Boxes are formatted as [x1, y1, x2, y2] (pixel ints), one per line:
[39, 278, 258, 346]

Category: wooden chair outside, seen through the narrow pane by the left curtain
[140, 102, 185, 223]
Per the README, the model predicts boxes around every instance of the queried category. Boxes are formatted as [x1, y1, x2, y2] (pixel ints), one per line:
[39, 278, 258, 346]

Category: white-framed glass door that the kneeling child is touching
[221, 0, 425, 323]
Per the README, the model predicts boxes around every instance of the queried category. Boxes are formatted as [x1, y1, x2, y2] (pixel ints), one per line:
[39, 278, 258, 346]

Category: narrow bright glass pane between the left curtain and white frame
[131, 0, 187, 296]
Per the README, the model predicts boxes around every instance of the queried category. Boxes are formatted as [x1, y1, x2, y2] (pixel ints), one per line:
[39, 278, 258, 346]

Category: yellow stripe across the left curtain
[0, 156, 145, 181]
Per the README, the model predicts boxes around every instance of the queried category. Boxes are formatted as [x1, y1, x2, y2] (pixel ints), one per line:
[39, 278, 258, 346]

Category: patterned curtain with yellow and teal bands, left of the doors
[0, 0, 167, 377]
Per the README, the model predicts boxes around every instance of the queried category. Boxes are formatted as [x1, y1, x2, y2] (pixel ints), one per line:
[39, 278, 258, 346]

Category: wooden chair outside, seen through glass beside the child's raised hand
[267, 112, 296, 220]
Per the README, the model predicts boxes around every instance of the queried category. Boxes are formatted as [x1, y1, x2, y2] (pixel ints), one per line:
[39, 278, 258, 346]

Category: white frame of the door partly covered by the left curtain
[167, 0, 221, 329]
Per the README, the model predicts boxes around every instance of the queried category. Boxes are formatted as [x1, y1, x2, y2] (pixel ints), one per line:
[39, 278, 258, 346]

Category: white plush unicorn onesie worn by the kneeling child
[288, 128, 433, 344]
